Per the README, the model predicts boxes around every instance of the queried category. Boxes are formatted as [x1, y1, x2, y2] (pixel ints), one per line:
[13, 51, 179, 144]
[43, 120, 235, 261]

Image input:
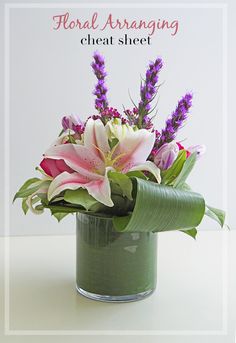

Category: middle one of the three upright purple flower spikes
[138, 58, 163, 127]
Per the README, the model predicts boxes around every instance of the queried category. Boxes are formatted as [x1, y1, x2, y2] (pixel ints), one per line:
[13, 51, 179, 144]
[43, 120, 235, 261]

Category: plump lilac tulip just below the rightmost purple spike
[154, 142, 179, 170]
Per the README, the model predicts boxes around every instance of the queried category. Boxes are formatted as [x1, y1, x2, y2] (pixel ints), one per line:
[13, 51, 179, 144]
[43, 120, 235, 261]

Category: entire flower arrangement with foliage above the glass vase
[14, 52, 225, 238]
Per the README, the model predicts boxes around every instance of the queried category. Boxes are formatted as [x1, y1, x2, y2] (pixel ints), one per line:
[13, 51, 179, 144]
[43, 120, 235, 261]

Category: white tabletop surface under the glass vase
[0, 231, 236, 342]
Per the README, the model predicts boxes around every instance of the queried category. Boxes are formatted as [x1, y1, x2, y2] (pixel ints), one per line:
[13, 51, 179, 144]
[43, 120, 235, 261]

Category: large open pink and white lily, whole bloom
[45, 118, 161, 207]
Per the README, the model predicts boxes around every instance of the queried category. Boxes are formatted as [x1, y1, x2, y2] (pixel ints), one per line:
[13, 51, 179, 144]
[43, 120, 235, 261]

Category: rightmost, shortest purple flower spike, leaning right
[157, 93, 192, 147]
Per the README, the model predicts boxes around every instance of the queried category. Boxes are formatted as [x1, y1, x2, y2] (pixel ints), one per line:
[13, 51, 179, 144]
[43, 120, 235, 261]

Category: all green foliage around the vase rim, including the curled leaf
[13, 160, 225, 239]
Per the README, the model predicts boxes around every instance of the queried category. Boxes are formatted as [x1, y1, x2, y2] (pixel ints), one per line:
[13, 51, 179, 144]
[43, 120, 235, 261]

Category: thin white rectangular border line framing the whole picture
[4, 3, 228, 336]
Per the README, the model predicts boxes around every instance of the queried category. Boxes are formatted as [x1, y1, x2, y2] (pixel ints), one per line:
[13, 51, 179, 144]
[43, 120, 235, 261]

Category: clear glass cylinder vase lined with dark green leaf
[76, 213, 157, 302]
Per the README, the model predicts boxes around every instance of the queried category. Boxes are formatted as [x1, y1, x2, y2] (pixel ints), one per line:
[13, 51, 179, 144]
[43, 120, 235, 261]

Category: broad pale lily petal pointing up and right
[112, 129, 155, 173]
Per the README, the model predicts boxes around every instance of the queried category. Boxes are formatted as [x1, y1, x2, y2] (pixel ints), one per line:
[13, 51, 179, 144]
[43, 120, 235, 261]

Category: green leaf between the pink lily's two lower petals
[64, 188, 98, 211]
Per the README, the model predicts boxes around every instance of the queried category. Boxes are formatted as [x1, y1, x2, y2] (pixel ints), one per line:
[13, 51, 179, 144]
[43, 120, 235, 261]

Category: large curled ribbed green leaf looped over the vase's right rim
[113, 178, 205, 232]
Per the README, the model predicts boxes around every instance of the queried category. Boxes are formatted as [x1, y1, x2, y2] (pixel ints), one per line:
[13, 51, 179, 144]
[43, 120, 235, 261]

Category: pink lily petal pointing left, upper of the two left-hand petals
[45, 144, 105, 179]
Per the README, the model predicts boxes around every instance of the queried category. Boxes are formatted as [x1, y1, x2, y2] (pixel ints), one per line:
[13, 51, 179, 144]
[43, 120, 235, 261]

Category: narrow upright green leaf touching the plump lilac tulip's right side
[161, 150, 187, 185]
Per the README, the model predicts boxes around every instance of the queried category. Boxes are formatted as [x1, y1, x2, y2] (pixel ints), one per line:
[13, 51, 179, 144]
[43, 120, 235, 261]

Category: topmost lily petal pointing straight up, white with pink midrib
[84, 118, 110, 159]
